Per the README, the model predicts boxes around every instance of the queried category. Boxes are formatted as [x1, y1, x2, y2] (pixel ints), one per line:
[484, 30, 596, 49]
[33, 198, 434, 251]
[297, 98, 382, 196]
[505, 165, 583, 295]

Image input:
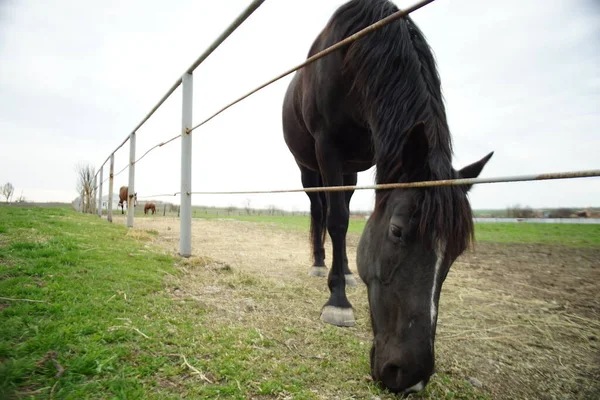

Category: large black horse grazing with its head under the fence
[283, 0, 493, 393]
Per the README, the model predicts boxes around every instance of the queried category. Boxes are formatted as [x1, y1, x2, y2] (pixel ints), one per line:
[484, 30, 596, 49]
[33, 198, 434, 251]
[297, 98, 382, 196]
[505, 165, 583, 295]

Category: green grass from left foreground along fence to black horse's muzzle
[0, 206, 482, 399]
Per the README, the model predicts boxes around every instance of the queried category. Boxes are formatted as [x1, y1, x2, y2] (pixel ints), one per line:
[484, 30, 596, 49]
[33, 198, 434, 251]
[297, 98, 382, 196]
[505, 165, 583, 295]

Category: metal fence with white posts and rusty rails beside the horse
[94, 0, 600, 257]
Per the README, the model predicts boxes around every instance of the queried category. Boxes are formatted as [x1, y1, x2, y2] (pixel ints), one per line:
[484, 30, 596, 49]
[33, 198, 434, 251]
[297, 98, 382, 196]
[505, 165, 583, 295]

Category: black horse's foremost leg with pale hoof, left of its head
[317, 138, 356, 326]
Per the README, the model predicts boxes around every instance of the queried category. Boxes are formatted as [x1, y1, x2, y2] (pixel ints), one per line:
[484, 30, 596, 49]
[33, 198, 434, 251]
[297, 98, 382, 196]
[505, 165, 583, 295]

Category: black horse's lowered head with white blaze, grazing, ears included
[357, 124, 492, 393]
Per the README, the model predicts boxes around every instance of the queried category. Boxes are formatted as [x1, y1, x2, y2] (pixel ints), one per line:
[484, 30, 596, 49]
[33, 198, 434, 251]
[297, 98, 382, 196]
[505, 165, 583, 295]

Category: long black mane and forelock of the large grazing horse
[330, 0, 473, 257]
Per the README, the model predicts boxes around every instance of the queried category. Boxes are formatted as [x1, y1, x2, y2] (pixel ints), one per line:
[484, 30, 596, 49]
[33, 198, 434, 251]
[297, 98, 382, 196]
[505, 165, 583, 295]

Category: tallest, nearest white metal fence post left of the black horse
[179, 72, 194, 257]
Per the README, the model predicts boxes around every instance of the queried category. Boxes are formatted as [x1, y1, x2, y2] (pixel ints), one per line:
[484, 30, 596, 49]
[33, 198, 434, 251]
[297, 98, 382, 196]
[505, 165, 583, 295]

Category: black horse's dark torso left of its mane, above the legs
[283, 6, 373, 173]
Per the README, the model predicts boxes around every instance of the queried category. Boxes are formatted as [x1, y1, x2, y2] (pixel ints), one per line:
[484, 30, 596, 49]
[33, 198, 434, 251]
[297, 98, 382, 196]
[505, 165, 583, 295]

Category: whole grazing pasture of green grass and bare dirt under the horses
[0, 206, 600, 399]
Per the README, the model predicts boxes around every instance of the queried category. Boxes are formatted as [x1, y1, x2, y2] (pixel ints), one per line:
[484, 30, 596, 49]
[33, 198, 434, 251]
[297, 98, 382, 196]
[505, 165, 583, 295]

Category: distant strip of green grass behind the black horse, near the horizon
[193, 213, 600, 247]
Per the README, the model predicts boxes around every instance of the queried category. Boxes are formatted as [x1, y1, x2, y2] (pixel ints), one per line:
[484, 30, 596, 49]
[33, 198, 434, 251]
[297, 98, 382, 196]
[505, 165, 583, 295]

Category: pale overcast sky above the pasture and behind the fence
[0, 0, 600, 210]
